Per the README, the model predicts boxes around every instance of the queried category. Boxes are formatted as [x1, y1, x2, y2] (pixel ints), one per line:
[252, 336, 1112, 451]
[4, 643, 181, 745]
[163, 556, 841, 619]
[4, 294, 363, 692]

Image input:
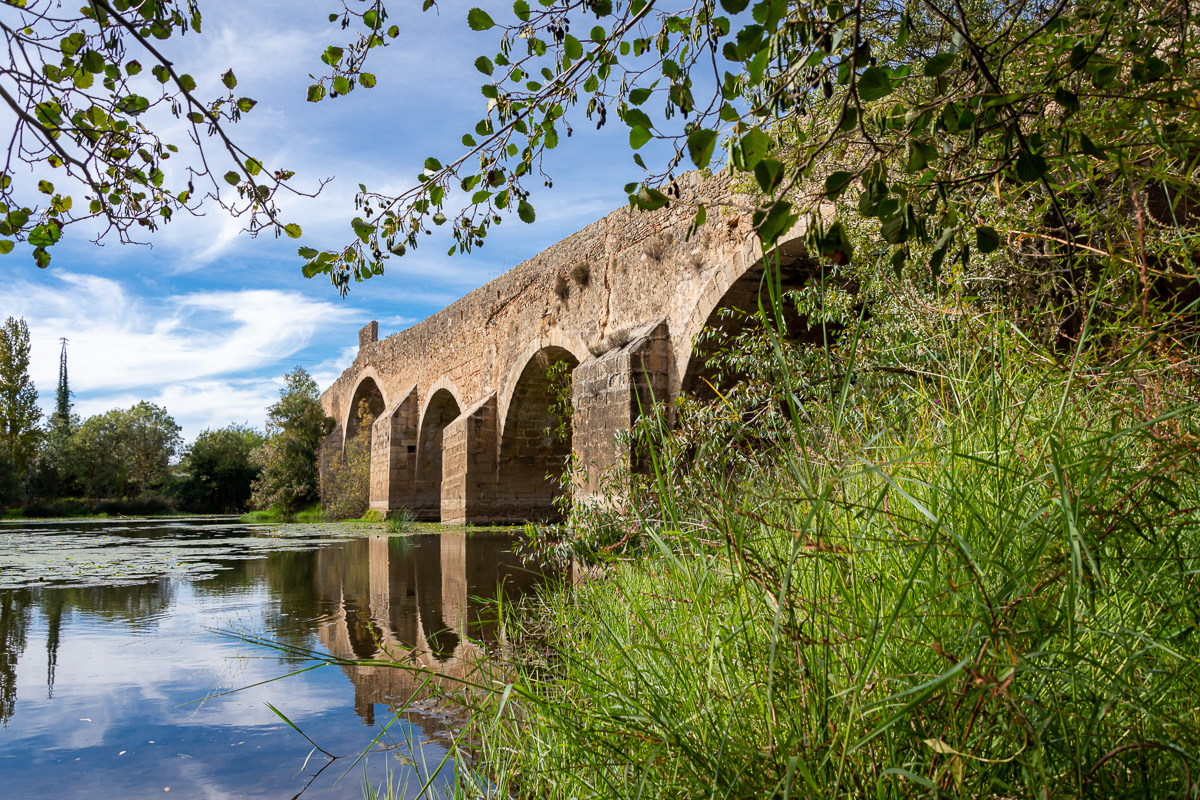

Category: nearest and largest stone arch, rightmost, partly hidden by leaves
[671, 233, 820, 397]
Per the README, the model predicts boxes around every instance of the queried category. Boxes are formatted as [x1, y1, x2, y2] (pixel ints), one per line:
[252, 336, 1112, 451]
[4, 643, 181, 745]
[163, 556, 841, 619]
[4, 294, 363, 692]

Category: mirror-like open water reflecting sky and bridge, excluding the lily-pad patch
[0, 525, 549, 799]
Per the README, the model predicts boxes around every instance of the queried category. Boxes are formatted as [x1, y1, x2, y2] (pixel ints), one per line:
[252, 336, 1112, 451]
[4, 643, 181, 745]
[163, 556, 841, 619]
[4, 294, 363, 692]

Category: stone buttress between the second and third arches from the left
[442, 392, 498, 525]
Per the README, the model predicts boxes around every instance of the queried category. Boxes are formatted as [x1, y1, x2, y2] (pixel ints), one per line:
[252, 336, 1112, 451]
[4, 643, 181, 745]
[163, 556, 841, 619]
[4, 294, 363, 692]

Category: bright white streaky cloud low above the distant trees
[6, 271, 362, 439]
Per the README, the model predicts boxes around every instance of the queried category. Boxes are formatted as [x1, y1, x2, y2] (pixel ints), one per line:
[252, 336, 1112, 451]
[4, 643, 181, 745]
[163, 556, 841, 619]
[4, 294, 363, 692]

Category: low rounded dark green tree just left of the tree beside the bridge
[174, 425, 265, 513]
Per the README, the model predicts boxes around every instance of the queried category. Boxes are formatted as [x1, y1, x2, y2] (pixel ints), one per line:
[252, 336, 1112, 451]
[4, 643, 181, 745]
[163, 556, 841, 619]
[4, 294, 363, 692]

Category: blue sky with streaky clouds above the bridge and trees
[0, 0, 642, 440]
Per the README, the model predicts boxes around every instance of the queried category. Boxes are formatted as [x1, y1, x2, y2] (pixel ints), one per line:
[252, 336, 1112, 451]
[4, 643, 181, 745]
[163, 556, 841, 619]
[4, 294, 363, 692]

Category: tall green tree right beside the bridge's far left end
[252, 367, 334, 513]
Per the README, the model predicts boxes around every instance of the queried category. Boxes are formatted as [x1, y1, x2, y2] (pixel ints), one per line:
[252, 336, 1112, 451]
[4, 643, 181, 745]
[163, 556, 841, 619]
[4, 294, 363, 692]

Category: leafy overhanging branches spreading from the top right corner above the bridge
[300, 0, 1200, 291]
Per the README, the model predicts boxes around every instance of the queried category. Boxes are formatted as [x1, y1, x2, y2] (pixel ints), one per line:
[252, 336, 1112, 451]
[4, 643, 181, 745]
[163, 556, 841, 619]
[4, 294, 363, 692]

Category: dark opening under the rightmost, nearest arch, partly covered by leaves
[680, 253, 824, 401]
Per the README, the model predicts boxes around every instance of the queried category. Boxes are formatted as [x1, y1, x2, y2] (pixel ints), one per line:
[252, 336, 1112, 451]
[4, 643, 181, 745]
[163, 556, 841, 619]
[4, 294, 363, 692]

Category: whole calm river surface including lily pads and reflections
[0, 521, 552, 799]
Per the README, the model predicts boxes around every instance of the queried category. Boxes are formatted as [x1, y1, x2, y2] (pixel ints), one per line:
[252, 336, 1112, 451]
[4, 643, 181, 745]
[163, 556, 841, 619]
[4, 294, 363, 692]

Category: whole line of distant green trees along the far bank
[0, 317, 334, 516]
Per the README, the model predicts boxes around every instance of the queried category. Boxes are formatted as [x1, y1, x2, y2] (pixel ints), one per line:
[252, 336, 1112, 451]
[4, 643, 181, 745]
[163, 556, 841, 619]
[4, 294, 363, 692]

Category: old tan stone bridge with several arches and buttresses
[320, 173, 816, 524]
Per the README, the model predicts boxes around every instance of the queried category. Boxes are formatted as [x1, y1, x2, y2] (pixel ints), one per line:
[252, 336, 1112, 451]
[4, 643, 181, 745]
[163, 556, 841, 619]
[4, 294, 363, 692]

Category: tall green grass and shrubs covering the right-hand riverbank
[458, 291, 1200, 798]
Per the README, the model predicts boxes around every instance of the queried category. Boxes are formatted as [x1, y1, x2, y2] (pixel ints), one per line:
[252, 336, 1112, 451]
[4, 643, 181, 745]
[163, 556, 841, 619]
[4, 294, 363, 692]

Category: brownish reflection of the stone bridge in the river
[314, 533, 546, 733]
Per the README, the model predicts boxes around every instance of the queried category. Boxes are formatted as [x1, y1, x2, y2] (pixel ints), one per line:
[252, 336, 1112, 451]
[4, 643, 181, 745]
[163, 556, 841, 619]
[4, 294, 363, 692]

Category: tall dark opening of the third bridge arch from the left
[497, 345, 580, 522]
